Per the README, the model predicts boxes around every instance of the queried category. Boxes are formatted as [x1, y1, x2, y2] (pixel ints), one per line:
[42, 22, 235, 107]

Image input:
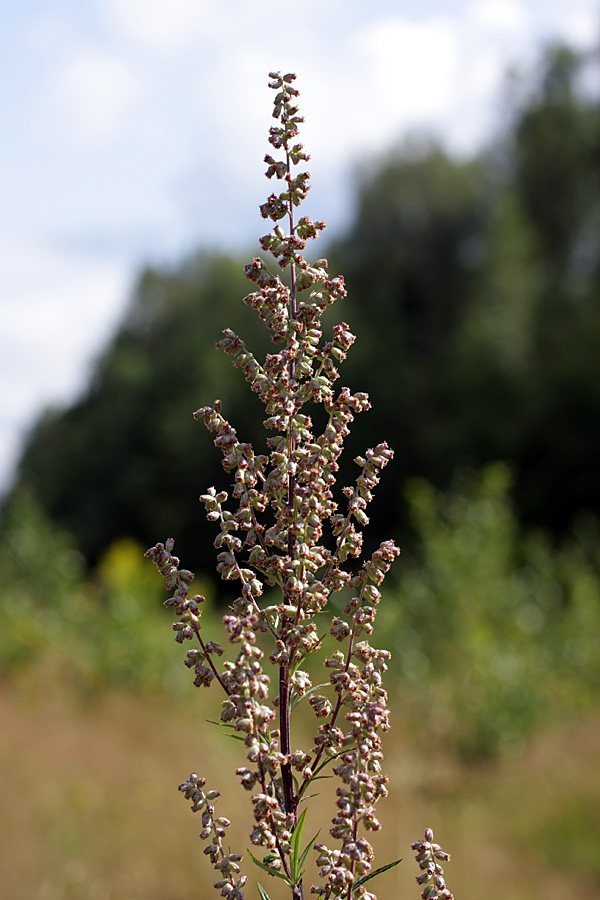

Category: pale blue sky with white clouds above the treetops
[0, 0, 600, 493]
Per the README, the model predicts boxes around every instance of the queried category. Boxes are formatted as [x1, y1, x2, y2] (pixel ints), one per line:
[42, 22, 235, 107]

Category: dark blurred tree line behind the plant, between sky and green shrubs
[7, 40, 600, 571]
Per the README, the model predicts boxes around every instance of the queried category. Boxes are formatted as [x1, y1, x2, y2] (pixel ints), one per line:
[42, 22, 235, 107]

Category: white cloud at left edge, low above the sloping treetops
[0, 233, 129, 492]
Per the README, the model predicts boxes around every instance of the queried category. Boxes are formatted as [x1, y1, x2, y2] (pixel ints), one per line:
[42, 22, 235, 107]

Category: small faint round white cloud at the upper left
[43, 47, 145, 150]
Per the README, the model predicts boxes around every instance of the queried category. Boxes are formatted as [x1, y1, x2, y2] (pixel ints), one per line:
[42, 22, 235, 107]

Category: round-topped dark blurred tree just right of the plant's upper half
[331, 143, 491, 515]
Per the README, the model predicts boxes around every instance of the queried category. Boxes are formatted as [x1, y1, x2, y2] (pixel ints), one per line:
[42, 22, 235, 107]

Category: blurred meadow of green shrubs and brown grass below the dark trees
[0, 464, 600, 900]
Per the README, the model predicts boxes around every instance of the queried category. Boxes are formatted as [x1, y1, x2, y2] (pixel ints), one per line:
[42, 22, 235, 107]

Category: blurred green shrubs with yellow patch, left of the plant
[0, 493, 218, 696]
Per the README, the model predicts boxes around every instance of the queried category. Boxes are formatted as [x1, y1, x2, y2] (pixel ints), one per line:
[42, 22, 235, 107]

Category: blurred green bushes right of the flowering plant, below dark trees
[382, 464, 600, 758]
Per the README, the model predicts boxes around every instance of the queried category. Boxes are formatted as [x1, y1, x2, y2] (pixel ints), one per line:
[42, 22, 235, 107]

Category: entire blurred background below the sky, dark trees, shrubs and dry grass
[0, 38, 600, 900]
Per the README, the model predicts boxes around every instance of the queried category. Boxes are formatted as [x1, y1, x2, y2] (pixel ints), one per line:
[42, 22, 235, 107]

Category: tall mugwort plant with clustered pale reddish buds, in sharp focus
[147, 72, 451, 900]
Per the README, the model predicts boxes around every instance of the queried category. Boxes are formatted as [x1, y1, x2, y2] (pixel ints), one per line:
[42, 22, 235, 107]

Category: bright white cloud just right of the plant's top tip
[272, 17, 459, 173]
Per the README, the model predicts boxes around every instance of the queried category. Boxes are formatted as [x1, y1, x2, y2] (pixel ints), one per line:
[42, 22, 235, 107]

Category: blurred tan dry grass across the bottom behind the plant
[0, 673, 600, 900]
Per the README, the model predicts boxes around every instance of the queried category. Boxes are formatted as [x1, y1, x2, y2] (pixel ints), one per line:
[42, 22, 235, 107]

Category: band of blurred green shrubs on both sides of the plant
[0, 474, 600, 774]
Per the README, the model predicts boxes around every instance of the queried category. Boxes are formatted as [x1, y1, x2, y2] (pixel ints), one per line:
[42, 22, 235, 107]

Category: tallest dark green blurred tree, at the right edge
[502, 46, 600, 531]
